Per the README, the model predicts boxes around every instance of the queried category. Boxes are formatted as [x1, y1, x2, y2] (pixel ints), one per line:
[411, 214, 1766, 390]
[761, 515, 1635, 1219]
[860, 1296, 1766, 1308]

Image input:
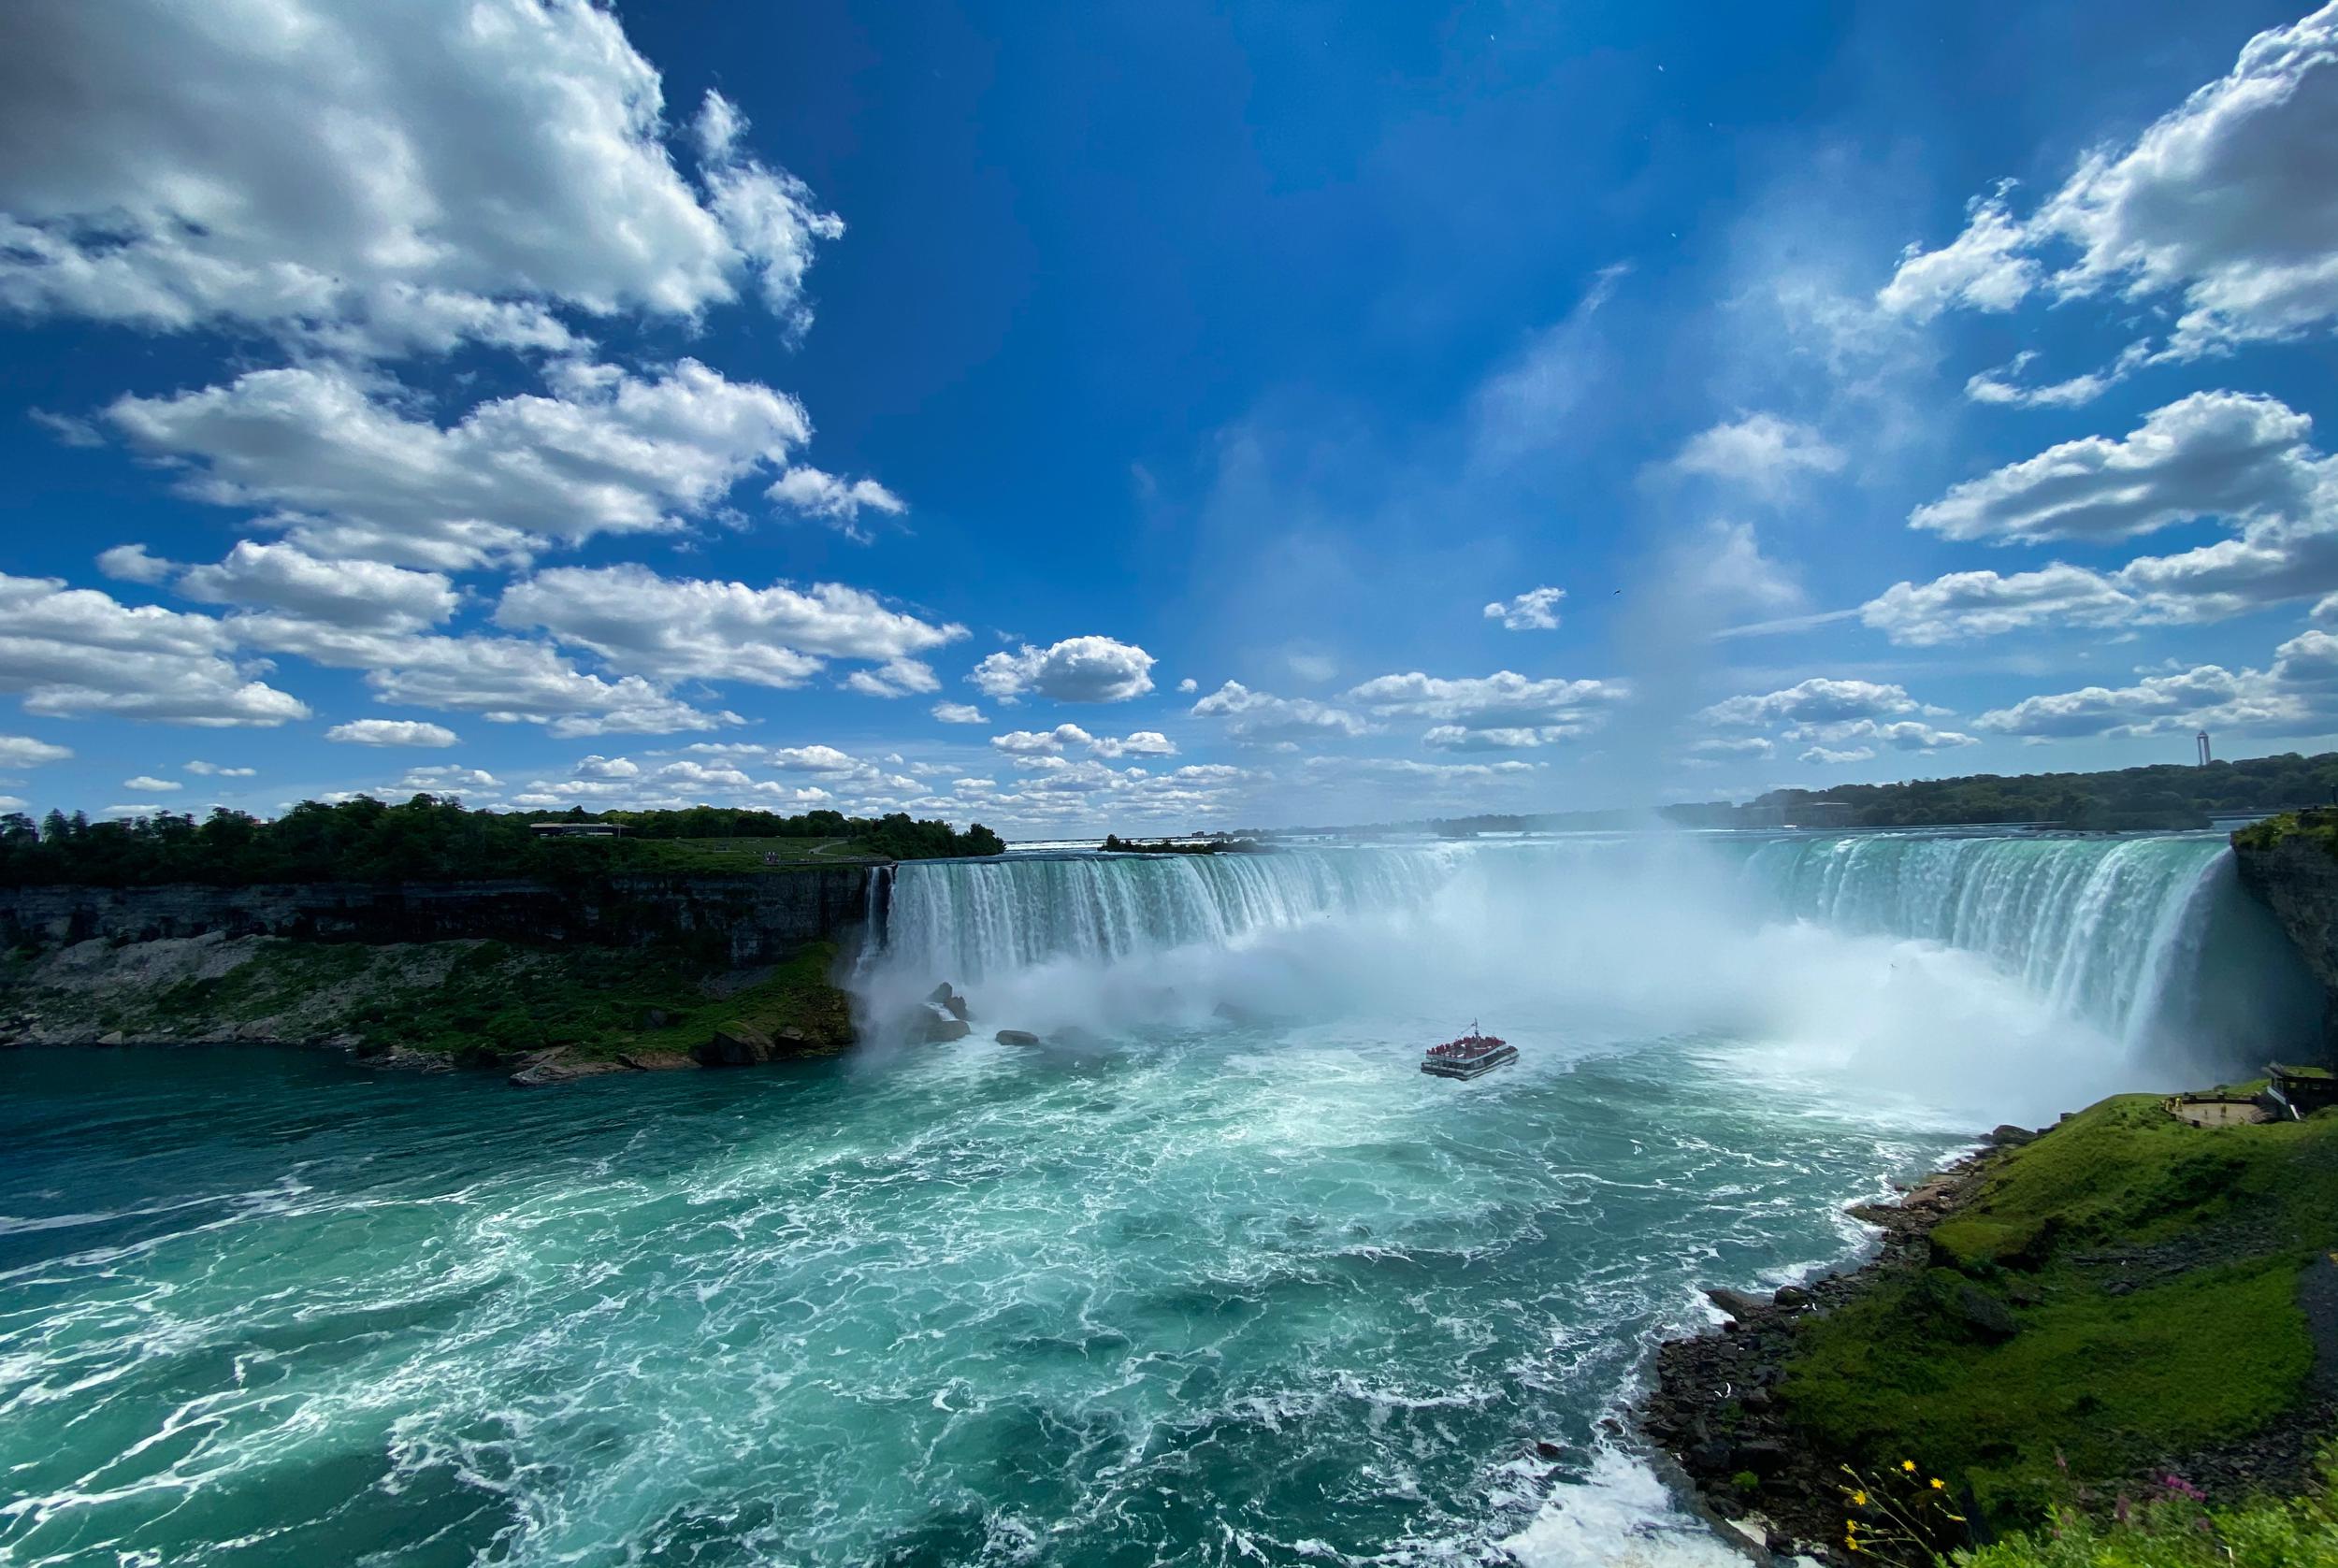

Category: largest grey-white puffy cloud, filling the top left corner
[0, 0, 842, 352]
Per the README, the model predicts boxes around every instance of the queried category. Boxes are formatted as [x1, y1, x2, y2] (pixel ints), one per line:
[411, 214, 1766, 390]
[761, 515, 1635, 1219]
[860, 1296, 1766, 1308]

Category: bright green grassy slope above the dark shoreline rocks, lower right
[1780, 1096, 2338, 1521]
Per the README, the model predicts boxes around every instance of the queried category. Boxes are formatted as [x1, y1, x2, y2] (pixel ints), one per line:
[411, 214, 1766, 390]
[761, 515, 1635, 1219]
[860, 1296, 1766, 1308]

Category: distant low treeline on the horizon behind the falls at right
[1234, 753, 2338, 839]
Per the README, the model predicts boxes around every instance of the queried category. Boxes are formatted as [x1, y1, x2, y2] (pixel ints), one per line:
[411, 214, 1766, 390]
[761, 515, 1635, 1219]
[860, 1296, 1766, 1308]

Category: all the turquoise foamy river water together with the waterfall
[0, 834, 2315, 1568]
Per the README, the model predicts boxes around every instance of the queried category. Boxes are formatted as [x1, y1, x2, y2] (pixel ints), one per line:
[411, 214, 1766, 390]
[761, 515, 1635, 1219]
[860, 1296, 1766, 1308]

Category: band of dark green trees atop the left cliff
[0, 795, 1005, 888]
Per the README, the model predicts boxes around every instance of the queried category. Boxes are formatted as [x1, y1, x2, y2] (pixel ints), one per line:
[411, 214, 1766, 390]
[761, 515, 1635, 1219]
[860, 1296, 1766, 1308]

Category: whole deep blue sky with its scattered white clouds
[0, 0, 2338, 837]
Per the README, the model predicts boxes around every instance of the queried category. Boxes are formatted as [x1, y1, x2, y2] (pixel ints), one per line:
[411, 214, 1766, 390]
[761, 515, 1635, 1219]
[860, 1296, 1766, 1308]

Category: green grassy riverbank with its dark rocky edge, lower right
[1639, 1096, 2338, 1561]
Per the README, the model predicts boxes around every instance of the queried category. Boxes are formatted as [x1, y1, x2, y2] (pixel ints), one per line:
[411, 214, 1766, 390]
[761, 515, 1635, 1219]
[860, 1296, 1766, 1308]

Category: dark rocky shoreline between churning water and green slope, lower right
[1635, 1127, 2037, 1563]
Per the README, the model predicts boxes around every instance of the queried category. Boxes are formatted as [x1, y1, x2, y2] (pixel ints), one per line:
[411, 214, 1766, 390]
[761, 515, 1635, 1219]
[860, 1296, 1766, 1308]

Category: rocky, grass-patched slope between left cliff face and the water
[0, 930, 854, 1086]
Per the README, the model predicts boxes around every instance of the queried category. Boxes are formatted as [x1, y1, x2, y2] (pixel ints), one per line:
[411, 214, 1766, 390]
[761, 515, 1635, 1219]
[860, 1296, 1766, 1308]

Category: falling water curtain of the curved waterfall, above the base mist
[870, 832, 2319, 1058]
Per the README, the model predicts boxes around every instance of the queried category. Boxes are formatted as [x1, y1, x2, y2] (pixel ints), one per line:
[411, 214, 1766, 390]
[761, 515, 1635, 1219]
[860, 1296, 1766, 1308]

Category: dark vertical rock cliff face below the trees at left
[0, 867, 870, 968]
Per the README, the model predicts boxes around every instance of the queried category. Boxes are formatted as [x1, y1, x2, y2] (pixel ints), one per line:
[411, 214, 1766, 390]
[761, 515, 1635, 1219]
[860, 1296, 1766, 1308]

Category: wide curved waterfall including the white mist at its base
[860, 832, 2319, 1119]
